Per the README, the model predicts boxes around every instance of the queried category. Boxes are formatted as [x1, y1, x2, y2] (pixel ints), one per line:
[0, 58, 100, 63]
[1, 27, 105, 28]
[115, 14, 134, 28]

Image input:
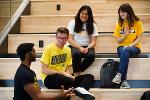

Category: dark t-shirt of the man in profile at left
[13, 64, 38, 100]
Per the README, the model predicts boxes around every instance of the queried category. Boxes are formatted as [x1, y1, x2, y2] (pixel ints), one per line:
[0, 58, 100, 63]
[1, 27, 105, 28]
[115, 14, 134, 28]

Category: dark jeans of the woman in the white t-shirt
[69, 46, 95, 72]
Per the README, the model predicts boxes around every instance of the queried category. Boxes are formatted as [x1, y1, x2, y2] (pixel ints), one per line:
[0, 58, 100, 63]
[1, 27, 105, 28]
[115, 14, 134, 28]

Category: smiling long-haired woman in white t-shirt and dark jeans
[68, 5, 98, 75]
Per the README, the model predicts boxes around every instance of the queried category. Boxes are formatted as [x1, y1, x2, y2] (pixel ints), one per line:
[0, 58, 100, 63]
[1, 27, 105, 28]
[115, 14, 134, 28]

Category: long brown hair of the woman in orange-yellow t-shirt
[118, 3, 140, 27]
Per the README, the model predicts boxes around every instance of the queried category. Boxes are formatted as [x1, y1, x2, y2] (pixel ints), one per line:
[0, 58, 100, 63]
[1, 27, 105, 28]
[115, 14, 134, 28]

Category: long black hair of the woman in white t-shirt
[74, 5, 94, 35]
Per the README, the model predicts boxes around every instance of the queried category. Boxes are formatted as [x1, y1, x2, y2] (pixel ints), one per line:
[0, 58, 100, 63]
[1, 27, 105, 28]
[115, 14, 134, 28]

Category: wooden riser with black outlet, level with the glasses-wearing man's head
[8, 33, 150, 54]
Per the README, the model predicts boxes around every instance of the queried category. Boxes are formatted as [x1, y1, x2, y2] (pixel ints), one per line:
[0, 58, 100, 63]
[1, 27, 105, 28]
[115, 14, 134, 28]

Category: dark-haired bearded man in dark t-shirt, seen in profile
[13, 43, 72, 100]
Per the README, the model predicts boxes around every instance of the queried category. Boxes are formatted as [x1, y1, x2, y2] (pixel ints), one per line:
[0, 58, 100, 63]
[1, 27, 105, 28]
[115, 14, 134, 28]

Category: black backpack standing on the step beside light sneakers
[100, 59, 120, 88]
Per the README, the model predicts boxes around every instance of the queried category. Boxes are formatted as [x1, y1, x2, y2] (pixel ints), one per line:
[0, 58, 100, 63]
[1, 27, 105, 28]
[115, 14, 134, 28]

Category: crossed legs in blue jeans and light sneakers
[112, 46, 140, 88]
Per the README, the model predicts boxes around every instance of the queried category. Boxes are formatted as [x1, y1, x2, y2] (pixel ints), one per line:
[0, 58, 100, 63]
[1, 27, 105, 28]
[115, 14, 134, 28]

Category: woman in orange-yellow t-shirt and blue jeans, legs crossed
[112, 3, 143, 88]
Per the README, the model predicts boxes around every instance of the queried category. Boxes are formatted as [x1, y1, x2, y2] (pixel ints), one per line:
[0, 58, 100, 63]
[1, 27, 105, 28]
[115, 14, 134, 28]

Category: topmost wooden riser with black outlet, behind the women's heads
[31, 0, 150, 15]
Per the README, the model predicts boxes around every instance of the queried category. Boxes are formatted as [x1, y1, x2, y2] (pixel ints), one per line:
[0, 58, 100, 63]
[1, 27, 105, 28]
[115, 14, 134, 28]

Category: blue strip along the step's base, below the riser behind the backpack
[0, 80, 150, 88]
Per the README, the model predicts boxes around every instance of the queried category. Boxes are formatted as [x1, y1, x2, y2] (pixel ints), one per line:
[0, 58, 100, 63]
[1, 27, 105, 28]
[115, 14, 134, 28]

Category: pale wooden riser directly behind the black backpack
[0, 58, 150, 80]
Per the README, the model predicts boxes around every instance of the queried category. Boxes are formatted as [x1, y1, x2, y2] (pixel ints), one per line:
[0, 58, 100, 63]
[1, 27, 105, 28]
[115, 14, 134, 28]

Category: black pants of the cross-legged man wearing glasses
[44, 74, 94, 90]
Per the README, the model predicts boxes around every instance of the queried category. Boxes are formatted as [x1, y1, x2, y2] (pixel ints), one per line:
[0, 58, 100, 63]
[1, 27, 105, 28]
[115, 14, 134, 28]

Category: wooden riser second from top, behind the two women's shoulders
[20, 14, 150, 33]
